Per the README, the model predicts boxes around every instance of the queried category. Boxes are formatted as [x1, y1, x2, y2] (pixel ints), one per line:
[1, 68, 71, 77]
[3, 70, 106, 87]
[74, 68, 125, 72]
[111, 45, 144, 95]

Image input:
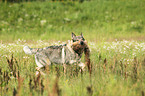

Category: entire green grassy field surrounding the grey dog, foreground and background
[0, 0, 145, 96]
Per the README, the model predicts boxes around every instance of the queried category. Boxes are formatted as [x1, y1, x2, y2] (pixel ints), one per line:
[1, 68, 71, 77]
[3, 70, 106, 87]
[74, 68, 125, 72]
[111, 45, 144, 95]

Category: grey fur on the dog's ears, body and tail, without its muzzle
[23, 33, 84, 68]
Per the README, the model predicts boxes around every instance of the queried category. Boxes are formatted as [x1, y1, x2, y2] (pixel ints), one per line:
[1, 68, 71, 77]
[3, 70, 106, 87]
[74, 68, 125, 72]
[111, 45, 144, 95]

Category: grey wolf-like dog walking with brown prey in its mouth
[23, 33, 90, 72]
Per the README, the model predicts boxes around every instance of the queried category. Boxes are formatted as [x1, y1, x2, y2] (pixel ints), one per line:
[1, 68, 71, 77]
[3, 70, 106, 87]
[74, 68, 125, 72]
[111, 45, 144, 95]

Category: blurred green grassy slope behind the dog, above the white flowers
[0, 0, 145, 42]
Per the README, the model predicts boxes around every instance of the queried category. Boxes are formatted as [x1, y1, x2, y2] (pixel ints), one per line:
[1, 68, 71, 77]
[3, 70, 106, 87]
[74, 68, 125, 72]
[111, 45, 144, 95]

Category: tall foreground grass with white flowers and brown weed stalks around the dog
[0, 40, 145, 96]
